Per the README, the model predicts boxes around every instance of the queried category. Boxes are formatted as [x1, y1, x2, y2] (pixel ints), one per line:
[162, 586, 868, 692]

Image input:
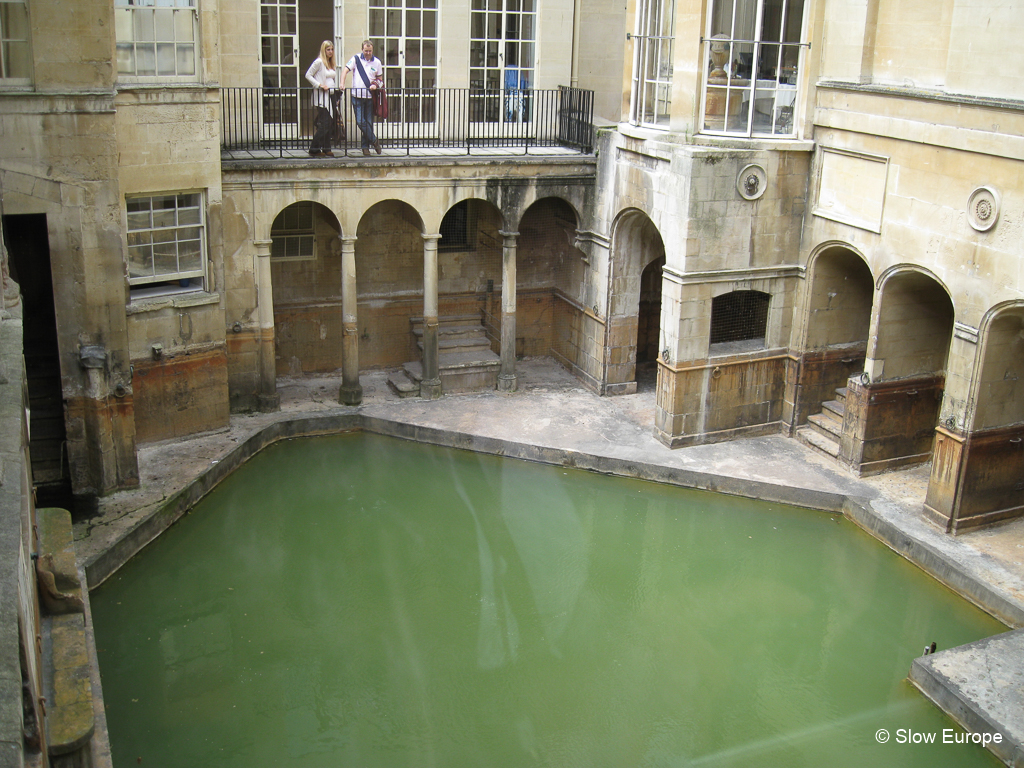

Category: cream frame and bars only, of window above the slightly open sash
[114, 0, 200, 84]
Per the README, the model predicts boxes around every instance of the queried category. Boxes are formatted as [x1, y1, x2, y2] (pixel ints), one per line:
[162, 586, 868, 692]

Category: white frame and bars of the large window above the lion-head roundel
[697, 0, 810, 139]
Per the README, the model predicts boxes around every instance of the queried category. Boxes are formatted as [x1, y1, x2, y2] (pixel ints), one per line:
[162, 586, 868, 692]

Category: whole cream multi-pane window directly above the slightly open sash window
[114, 0, 199, 78]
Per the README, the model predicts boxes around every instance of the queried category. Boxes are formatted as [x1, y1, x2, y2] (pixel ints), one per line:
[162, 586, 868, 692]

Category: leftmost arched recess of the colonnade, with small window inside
[270, 201, 342, 376]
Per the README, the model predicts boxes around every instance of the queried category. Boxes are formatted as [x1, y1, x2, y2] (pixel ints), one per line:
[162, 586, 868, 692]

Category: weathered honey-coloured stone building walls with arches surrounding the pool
[0, 0, 1024, 529]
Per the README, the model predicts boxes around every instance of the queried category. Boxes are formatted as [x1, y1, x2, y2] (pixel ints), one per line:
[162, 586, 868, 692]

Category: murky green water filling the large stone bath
[92, 434, 1005, 768]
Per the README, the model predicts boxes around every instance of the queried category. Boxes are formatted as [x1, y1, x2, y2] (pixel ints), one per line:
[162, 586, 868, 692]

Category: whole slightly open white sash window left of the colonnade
[126, 193, 206, 297]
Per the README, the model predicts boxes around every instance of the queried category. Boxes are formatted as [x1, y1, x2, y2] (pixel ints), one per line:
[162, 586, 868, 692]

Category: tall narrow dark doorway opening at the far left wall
[3, 213, 74, 511]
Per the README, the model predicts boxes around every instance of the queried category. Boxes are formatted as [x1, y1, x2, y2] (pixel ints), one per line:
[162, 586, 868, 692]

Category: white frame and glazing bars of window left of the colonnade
[124, 189, 210, 300]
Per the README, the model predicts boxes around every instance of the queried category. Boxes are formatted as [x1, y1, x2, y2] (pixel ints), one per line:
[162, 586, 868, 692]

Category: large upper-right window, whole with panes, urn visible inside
[702, 0, 804, 136]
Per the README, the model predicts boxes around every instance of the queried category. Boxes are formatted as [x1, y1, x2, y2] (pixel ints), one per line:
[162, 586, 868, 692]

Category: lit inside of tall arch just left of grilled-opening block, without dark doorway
[603, 209, 666, 394]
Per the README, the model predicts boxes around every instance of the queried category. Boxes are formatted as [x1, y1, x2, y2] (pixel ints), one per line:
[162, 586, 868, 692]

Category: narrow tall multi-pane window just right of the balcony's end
[630, 0, 675, 128]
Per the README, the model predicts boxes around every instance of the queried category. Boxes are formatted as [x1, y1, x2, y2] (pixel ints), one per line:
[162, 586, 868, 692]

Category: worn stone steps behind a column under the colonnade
[387, 314, 501, 397]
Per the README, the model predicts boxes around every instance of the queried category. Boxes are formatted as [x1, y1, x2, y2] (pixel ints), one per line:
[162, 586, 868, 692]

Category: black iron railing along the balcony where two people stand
[221, 87, 594, 157]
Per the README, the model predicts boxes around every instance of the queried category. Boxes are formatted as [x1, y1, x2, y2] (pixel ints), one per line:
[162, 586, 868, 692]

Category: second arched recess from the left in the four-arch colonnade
[355, 199, 424, 369]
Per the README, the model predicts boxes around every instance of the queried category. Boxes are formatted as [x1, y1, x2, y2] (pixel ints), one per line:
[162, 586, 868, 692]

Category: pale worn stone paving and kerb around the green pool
[75, 358, 1024, 765]
